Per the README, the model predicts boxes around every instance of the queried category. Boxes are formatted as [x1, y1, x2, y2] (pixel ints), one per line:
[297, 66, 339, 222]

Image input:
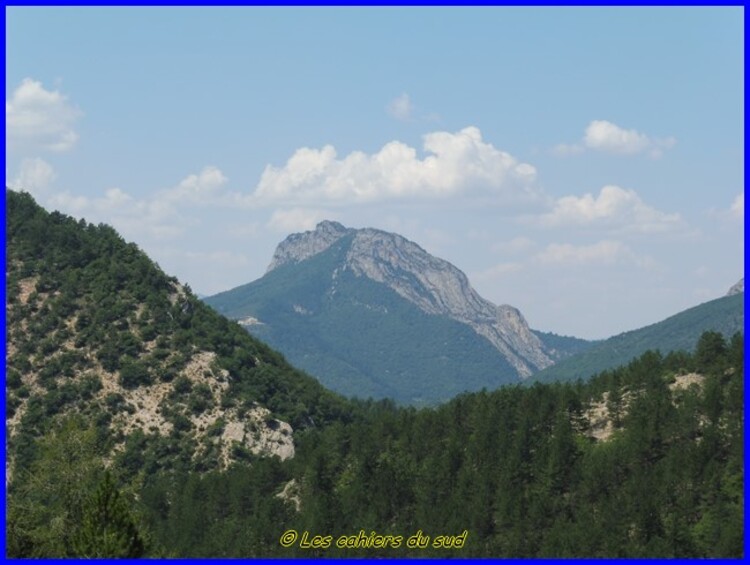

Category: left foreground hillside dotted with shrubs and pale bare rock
[6, 190, 351, 555]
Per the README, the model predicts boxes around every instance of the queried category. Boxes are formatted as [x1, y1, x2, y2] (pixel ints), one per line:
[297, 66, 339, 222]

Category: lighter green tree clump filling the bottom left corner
[6, 418, 146, 557]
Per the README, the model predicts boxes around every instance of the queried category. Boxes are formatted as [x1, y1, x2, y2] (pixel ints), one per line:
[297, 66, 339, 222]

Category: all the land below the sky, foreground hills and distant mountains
[6, 189, 744, 558]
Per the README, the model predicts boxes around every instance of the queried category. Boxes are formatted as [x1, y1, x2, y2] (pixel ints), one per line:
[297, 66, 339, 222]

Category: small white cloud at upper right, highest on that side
[552, 120, 677, 159]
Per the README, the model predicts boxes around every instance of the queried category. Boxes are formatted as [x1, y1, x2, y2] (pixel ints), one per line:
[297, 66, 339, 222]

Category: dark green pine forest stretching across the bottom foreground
[7, 333, 744, 558]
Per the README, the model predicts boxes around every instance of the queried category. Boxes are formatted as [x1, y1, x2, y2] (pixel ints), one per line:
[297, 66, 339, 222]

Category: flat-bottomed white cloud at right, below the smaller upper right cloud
[538, 185, 682, 233]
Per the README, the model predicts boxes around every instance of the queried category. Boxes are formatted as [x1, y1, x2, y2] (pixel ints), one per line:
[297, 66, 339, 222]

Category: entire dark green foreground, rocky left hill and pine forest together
[6, 191, 744, 557]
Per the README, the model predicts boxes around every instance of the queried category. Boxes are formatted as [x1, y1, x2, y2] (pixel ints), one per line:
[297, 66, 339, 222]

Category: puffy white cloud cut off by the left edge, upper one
[5, 78, 82, 151]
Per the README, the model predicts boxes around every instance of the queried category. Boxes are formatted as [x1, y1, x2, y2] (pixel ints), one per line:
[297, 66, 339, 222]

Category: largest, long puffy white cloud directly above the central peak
[253, 127, 536, 204]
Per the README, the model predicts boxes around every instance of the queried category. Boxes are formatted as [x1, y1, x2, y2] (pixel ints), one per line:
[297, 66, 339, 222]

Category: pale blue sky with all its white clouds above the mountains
[5, 7, 744, 338]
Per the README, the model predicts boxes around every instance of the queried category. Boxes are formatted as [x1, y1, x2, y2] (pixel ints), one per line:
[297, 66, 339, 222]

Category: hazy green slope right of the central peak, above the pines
[532, 292, 745, 382]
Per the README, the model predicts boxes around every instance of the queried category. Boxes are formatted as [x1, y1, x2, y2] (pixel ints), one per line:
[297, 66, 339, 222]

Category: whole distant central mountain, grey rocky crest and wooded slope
[205, 222, 585, 405]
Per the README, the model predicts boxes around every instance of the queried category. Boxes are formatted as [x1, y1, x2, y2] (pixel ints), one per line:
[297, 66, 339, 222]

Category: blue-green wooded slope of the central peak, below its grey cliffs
[207, 236, 517, 405]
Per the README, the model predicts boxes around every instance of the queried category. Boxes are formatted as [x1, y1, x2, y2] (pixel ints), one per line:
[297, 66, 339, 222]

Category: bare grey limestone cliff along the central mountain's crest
[268, 221, 553, 377]
